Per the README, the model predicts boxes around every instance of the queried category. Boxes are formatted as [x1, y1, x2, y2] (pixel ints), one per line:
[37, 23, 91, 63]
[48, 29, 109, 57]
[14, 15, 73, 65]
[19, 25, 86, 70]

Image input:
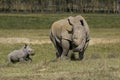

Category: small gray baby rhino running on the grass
[8, 44, 35, 63]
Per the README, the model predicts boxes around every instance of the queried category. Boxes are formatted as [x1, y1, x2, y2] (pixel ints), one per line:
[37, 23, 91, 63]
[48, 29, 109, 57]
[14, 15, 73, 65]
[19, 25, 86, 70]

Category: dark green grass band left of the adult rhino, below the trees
[0, 14, 73, 29]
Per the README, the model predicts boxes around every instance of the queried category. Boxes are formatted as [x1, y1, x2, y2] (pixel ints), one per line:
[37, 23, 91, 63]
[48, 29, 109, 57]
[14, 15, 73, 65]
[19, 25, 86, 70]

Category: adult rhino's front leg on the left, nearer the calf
[61, 39, 70, 58]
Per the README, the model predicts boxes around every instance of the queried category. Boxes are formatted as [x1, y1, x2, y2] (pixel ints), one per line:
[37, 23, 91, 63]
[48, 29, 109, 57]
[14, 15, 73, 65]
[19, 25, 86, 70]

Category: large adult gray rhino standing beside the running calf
[50, 15, 90, 60]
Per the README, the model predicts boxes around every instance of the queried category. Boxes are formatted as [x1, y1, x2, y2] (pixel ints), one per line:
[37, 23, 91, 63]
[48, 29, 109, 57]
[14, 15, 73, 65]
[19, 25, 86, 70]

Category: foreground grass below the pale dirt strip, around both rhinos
[0, 44, 120, 80]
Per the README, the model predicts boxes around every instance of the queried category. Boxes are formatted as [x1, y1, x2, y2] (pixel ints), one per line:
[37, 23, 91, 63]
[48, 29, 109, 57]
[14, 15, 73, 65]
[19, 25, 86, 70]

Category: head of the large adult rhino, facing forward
[68, 16, 86, 51]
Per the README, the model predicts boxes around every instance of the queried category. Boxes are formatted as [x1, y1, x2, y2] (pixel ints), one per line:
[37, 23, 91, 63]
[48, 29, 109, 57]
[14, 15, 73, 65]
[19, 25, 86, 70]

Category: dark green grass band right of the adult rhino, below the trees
[83, 14, 120, 28]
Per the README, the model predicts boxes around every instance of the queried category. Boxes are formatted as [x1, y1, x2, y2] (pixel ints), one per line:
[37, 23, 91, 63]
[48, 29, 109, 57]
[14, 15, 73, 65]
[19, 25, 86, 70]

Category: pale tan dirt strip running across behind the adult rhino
[0, 37, 120, 45]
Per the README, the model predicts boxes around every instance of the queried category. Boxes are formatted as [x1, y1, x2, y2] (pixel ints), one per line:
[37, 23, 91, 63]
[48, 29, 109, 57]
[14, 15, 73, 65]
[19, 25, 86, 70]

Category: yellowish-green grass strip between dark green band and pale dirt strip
[0, 28, 120, 39]
